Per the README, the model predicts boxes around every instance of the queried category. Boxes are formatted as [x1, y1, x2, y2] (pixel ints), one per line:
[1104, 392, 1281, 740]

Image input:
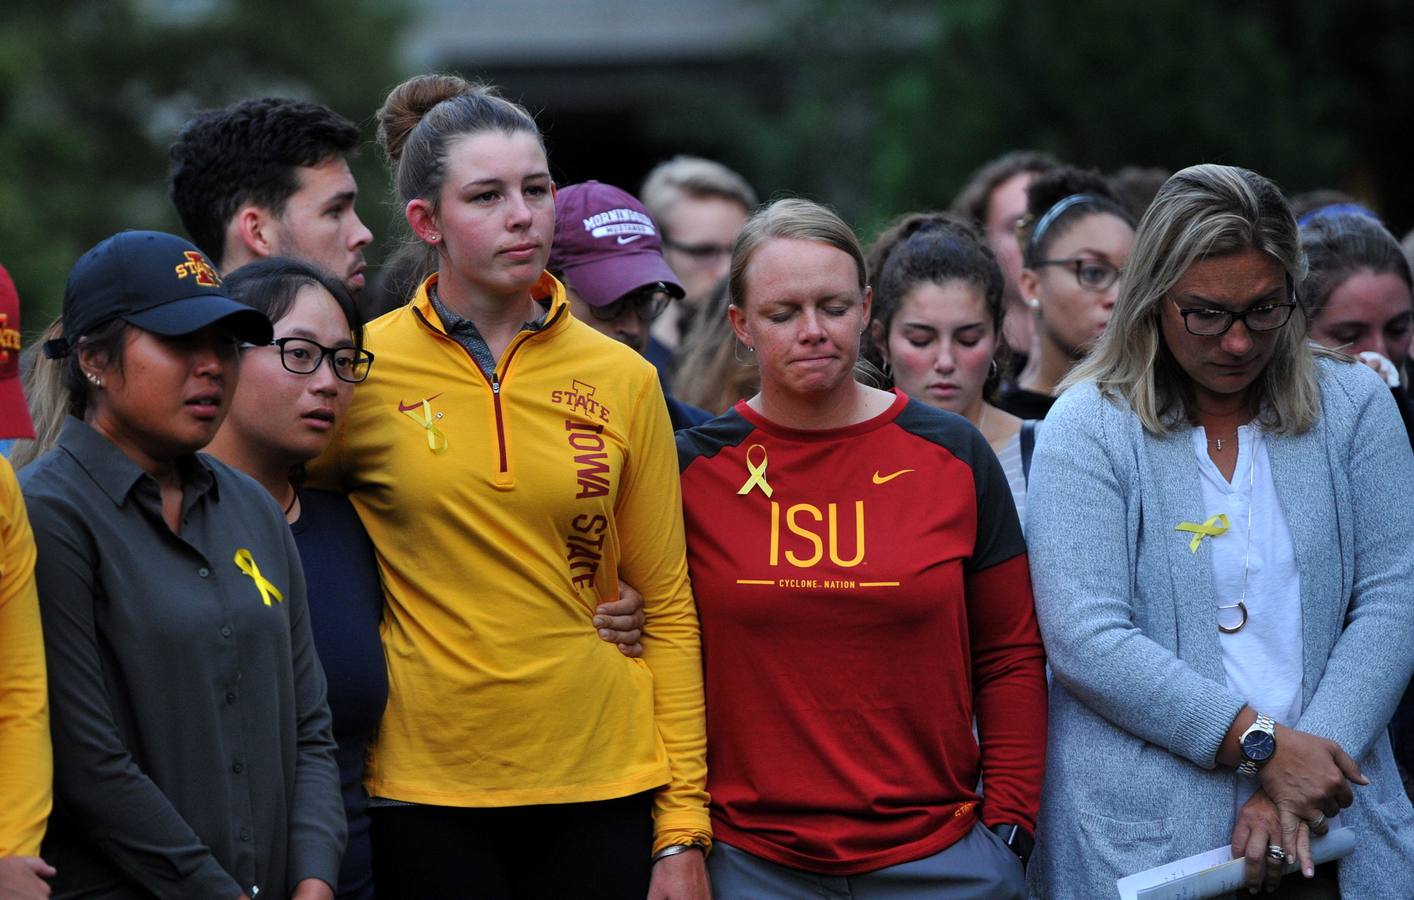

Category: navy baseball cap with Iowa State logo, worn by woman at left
[44, 231, 274, 359]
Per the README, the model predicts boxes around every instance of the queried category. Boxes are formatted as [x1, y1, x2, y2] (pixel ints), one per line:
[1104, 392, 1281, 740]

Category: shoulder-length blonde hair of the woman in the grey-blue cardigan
[1061, 164, 1321, 434]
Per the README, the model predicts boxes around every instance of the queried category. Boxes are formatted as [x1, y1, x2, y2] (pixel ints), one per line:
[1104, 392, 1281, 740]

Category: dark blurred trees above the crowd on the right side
[644, 0, 1414, 241]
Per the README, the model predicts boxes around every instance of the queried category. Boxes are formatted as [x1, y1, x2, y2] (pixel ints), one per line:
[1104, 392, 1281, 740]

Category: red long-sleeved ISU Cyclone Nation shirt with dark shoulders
[677, 393, 1046, 875]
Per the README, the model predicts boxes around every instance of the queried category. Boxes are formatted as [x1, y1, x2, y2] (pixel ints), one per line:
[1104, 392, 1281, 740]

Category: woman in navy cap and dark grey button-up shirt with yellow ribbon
[23, 232, 345, 900]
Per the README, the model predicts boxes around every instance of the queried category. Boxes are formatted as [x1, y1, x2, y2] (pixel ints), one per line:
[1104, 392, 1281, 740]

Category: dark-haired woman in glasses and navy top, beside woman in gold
[208, 256, 387, 900]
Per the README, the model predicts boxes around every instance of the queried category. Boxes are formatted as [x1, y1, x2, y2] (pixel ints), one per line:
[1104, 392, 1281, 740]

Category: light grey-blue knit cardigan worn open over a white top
[1027, 359, 1414, 900]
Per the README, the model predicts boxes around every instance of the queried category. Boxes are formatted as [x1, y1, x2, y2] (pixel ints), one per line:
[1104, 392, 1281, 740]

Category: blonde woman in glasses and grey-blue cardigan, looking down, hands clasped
[1027, 166, 1414, 899]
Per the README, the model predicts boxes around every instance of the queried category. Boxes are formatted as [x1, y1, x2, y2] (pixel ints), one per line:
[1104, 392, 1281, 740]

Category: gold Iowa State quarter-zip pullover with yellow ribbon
[311, 275, 710, 849]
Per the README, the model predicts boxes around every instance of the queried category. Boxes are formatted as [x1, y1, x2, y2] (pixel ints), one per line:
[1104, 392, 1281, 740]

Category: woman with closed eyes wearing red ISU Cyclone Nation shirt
[677, 200, 1045, 897]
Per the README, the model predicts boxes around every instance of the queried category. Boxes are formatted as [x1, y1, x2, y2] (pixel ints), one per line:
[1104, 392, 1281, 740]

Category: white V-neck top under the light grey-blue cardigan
[1193, 425, 1302, 809]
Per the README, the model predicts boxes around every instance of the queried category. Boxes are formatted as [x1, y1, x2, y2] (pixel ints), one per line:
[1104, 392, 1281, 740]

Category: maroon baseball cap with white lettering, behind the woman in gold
[549, 181, 684, 306]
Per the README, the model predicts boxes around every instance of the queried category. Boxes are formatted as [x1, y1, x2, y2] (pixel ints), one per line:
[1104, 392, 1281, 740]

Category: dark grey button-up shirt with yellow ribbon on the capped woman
[21, 419, 345, 900]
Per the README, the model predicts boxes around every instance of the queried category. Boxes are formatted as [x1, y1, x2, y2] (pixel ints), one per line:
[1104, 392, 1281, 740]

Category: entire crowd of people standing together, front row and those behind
[0, 75, 1414, 900]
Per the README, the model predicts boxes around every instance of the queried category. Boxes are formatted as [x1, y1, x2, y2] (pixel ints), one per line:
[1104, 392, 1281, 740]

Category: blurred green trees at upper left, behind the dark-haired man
[0, 0, 406, 334]
